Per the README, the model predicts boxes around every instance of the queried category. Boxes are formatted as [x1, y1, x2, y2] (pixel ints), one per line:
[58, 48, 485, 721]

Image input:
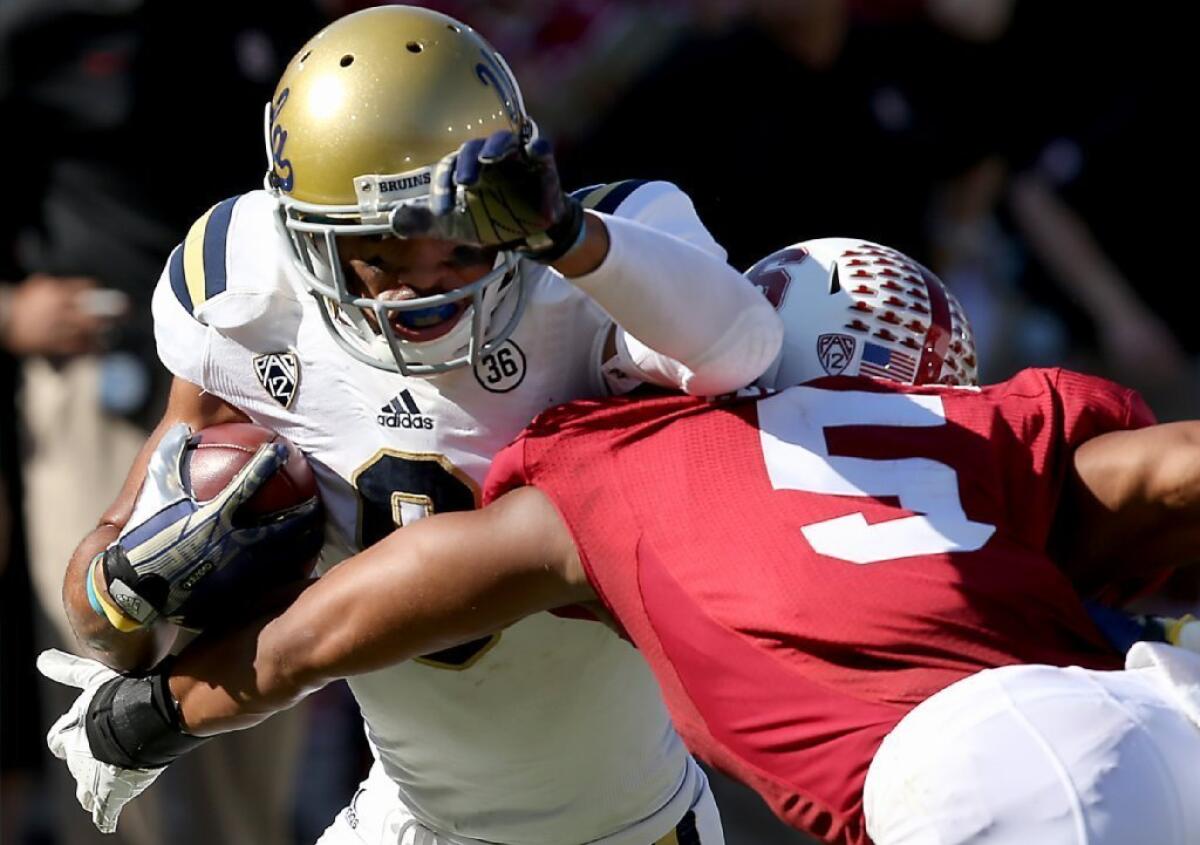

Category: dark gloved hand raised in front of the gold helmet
[391, 130, 583, 264]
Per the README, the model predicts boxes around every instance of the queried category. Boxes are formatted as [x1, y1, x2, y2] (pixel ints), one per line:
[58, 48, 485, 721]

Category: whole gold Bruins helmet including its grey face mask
[265, 6, 534, 376]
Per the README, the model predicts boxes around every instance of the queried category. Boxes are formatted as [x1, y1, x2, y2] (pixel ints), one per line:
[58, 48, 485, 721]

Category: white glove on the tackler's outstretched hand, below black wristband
[37, 649, 162, 833]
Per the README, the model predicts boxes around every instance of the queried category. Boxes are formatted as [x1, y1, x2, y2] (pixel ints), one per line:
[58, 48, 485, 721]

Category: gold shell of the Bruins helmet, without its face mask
[269, 6, 529, 205]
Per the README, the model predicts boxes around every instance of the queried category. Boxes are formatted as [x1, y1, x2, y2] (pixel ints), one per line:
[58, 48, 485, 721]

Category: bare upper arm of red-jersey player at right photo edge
[1064, 421, 1200, 594]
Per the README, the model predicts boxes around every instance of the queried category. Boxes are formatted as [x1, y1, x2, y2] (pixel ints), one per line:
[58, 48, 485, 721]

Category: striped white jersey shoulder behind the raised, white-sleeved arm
[571, 179, 726, 260]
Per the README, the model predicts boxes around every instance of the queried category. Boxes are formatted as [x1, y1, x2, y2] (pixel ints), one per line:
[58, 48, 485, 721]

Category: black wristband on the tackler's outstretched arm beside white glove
[85, 660, 209, 768]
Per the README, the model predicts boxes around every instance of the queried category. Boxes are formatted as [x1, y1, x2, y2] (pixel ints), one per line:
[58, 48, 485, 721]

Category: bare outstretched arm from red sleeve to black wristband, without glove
[169, 487, 594, 736]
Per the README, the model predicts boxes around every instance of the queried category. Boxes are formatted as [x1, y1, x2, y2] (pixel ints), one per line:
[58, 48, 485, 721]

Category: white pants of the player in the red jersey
[864, 643, 1200, 845]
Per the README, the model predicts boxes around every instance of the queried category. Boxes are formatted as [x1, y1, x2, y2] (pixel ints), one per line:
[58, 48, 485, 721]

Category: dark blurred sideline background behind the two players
[0, 0, 1185, 845]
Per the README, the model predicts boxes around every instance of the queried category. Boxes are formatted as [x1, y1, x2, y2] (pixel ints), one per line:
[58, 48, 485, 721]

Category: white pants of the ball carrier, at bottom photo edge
[317, 757, 725, 845]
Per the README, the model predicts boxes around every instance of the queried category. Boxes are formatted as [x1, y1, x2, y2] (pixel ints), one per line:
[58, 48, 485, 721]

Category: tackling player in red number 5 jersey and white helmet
[43, 241, 1200, 845]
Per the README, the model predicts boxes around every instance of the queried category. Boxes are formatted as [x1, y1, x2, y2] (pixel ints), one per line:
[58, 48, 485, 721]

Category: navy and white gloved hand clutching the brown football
[96, 424, 297, 630]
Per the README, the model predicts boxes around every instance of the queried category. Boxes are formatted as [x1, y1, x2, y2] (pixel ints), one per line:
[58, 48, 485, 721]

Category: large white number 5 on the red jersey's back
[758, 386, 996, 563]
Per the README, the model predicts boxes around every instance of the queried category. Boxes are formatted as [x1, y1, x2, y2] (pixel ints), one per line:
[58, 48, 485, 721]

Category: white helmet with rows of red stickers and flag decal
[745, 238, 979, 388]
